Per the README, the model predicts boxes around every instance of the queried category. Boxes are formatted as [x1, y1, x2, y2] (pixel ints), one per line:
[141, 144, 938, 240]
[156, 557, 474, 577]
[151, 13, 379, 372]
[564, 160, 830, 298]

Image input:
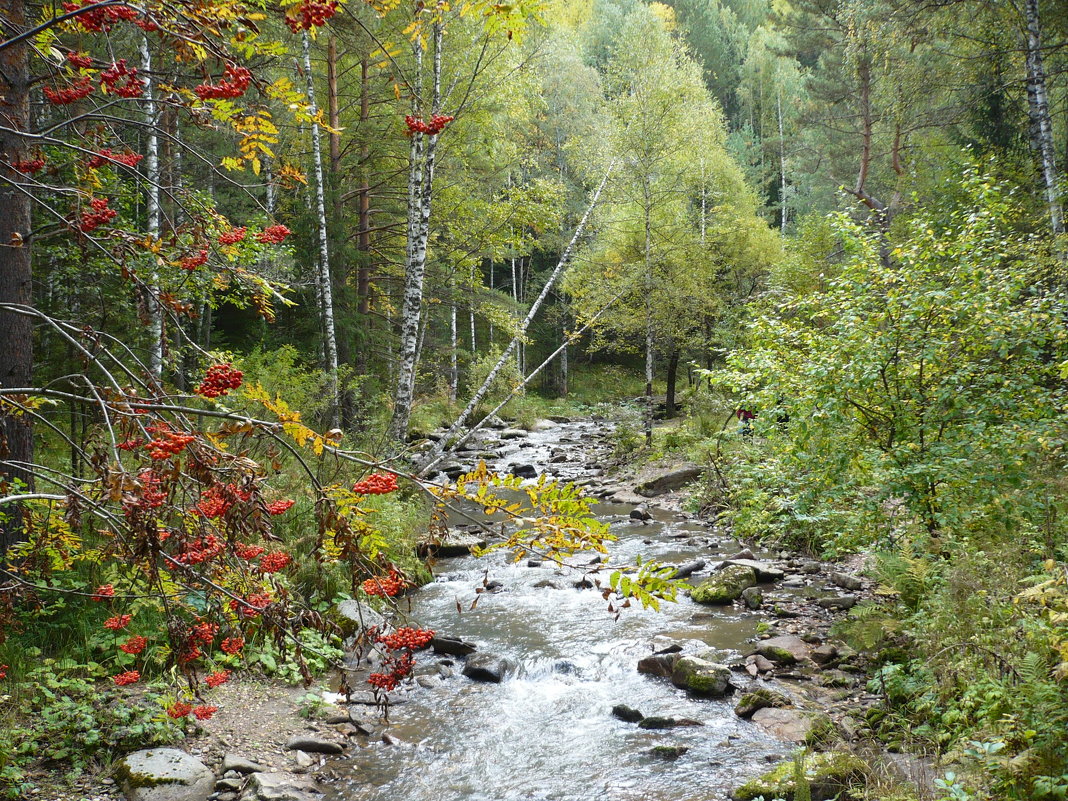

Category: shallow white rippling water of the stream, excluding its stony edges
[328, 422, 786, 801]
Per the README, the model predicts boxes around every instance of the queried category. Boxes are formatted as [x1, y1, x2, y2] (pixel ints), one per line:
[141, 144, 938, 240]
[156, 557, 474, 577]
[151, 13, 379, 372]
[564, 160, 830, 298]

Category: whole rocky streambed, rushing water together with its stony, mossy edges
[108, 420, 909, 801]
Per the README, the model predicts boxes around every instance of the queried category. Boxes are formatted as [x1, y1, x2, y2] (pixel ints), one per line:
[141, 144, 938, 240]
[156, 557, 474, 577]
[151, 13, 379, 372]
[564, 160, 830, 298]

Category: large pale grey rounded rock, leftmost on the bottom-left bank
[115, 749, 215, 801]
